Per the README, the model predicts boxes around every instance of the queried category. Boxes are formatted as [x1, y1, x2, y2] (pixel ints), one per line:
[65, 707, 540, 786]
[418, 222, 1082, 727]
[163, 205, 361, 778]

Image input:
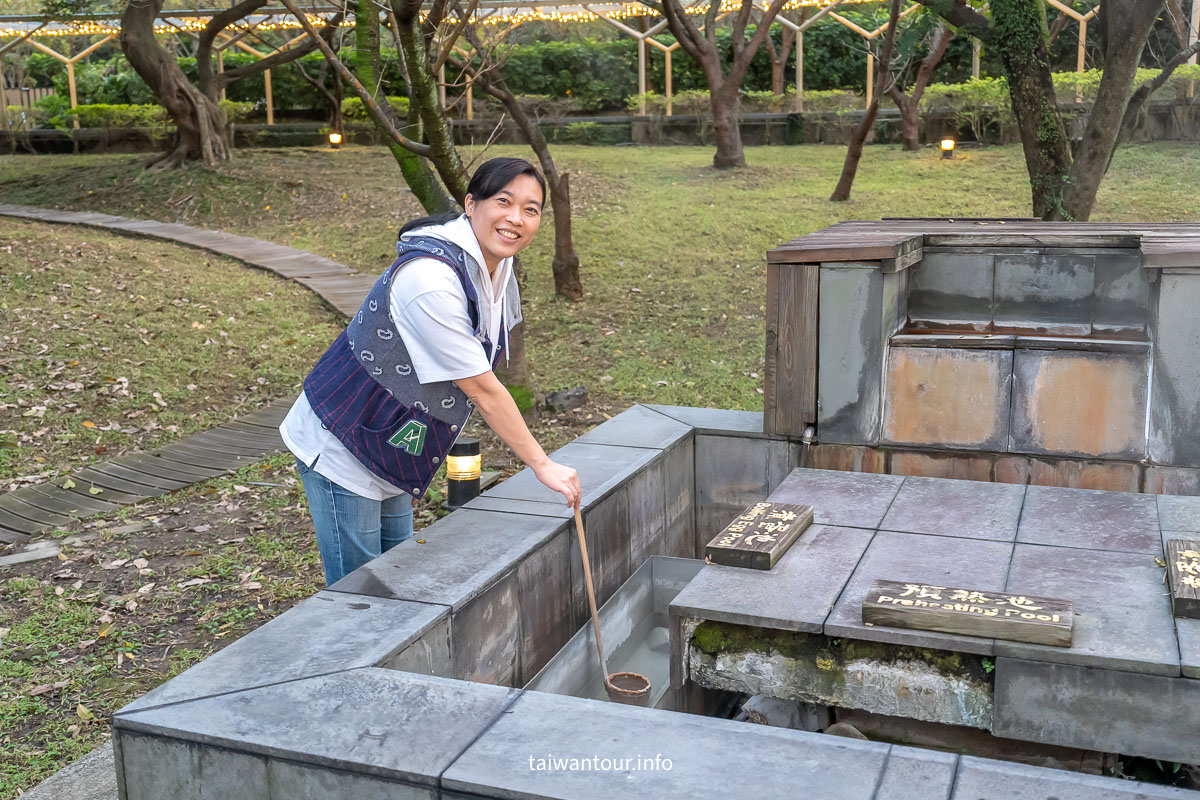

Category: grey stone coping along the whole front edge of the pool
[114, 668, 1200, 800]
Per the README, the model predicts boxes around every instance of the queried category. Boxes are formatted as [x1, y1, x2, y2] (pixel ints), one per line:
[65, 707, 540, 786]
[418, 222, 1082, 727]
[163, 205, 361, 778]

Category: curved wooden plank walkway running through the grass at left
[0, 204, 376, 546]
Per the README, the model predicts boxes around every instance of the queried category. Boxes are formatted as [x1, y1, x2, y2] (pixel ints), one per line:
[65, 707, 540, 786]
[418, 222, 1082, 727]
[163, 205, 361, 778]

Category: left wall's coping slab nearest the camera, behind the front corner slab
[116, 591, 449, 716]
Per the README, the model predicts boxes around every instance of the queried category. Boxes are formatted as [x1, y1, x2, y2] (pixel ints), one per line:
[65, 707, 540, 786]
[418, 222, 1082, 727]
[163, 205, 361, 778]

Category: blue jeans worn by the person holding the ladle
[296, 461, 413, 585]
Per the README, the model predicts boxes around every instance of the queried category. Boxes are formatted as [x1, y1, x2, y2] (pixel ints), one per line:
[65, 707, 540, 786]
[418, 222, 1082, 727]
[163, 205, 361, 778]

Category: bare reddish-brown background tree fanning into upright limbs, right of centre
[644, 0, 787, 169]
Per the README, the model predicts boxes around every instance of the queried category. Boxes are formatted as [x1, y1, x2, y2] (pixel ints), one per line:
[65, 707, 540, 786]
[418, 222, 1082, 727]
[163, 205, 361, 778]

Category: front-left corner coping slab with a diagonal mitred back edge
[114, 668, 523, 796]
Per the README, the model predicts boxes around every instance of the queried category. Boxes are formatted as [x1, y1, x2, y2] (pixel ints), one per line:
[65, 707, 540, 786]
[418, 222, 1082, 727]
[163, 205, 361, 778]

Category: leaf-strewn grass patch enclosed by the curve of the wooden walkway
[0, 217, 342, 491]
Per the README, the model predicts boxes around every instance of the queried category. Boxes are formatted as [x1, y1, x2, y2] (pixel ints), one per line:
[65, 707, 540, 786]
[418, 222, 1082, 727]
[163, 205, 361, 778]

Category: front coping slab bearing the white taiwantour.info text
[442, 691, 888, 800]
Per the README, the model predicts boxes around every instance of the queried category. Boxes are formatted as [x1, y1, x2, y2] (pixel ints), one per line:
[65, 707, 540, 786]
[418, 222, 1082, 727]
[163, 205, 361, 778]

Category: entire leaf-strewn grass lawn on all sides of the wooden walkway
[0, 144, 1200, 798]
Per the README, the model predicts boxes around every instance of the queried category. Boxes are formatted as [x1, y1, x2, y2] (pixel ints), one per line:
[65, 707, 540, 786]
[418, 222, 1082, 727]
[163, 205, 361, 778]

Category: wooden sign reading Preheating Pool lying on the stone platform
[863, 581, 1075, 648]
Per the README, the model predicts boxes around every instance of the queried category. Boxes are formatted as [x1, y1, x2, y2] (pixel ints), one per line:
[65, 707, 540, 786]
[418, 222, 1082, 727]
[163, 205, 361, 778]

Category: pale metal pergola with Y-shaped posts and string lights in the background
[0, 0, 1161, 127]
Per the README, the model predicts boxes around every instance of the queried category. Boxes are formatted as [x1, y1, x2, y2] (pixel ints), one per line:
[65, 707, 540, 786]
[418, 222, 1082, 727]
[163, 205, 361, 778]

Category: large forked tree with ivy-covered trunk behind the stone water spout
[919, 0, 1174, 219]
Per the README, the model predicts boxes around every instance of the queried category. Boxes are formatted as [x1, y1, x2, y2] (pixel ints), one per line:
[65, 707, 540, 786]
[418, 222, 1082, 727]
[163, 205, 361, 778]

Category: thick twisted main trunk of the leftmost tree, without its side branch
[118, 0, 233, 169]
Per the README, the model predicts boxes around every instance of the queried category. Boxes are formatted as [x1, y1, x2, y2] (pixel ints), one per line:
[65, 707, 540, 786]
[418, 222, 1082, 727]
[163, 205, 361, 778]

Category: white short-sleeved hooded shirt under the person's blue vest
[280, 215, 512, 500]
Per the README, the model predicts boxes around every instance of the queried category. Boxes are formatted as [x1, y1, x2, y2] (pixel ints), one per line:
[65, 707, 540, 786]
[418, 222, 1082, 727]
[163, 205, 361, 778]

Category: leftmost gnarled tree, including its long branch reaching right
[118, 0, 341, 169]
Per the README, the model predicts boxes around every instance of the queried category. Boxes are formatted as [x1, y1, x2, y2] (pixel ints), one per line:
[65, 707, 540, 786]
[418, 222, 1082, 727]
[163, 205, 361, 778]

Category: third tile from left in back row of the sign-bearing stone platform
[1016, 486, 1162, 553]
